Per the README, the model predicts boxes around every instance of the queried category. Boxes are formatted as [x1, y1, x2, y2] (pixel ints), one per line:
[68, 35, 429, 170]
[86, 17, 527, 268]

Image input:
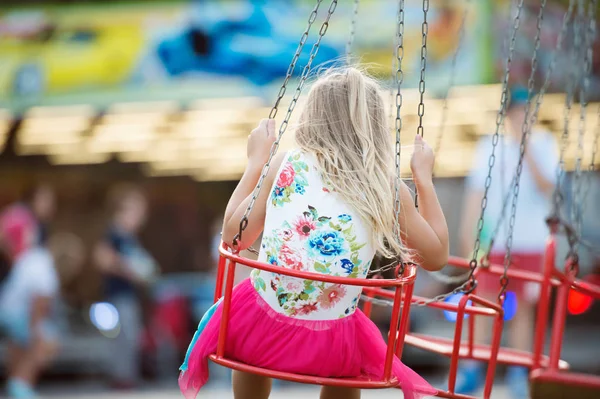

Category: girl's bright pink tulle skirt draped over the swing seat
[179, 279, 436, 399]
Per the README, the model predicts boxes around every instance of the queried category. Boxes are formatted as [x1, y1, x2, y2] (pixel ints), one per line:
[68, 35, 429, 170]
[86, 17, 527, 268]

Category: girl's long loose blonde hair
[296, 68, 410, 260]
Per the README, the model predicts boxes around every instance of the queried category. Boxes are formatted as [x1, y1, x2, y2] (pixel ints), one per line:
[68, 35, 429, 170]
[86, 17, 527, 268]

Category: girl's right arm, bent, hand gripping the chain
[400, 136, 449, 271]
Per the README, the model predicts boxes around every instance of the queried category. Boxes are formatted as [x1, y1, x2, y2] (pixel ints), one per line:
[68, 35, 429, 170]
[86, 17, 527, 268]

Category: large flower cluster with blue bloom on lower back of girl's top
[252, 205, 370, 317]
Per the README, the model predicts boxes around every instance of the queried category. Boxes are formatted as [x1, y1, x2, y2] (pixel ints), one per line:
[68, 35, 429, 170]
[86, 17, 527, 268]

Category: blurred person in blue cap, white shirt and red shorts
[456, 86, 558, 399]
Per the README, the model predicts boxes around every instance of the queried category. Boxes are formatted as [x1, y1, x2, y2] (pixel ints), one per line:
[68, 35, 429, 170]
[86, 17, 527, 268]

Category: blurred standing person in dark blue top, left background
[94, 186, 157, 389]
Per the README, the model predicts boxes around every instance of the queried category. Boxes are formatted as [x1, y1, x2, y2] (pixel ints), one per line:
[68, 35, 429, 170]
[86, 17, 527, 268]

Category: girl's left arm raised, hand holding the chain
[223, 119, 286, 250]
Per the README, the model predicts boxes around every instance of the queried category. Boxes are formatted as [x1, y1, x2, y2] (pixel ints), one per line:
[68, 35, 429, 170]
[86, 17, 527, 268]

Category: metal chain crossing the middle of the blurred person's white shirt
[498, 0, 546, 301]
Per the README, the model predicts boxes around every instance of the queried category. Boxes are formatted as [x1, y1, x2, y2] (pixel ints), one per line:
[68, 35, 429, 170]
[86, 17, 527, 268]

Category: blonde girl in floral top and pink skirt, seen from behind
[179, 68, 448, 399]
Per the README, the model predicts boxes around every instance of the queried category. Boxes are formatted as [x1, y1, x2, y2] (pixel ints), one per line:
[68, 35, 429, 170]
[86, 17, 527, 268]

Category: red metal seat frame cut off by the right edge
[530, 235, 600, 390]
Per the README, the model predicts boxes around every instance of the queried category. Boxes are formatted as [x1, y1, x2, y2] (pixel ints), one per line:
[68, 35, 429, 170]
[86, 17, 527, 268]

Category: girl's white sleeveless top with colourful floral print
[251, 150, 375, 320]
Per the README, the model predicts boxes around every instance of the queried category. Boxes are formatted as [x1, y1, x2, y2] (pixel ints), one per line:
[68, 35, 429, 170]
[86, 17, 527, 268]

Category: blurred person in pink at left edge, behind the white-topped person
[0, 184, 56, 282]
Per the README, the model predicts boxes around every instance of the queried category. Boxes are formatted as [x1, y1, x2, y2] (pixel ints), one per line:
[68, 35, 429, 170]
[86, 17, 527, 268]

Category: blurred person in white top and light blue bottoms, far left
[0, 233, 85, 399]
